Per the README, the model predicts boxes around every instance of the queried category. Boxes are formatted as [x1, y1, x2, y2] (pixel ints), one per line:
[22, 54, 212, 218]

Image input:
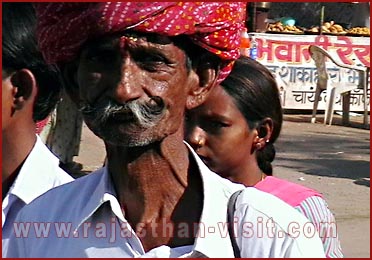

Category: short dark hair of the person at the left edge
[2, 3, 62, 122]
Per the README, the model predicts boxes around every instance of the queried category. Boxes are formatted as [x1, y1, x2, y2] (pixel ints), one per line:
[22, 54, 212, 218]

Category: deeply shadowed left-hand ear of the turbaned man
[61, 62, 80, 104]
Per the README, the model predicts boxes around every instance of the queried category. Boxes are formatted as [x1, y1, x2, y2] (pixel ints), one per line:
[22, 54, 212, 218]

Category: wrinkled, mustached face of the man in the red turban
[77, 34, 195, 146]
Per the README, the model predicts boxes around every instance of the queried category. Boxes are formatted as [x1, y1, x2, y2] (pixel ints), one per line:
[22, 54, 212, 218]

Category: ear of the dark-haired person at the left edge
[10, 69, 37, 110]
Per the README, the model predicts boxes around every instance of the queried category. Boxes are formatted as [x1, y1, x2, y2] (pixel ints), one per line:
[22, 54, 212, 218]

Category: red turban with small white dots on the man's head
[35, 2, 245, 80]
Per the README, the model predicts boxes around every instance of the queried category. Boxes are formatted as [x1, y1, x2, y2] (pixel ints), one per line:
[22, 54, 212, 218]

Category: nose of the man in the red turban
[114, 57, 144, 104]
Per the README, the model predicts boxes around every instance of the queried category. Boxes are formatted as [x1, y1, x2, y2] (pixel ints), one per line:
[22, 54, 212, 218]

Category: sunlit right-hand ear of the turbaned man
[186, 67, 218, 109]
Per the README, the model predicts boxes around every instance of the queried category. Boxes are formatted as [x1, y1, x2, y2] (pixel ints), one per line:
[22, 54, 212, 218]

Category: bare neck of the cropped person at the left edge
[2, 124, 36, 197]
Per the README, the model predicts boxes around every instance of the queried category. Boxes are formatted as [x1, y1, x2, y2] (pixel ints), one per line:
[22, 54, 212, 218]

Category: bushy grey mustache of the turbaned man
[80, 96, 165, 128]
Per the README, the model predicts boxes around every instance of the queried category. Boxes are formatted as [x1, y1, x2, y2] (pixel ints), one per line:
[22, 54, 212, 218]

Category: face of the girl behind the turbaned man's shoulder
[186, 87, 255, 178]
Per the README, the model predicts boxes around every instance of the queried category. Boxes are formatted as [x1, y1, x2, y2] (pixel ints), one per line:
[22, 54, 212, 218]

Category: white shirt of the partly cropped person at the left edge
[2, 136, 73, 256]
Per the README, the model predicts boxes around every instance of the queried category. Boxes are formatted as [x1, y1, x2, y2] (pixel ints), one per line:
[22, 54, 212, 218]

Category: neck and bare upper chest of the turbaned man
[106, 129, 203, 250]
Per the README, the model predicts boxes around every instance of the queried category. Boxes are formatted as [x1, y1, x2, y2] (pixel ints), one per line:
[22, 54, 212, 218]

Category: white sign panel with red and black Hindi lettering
[251, 33, 370, 111]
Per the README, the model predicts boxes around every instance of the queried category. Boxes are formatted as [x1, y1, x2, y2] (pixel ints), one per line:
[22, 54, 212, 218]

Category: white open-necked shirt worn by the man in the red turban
[3, 142, 324, 258]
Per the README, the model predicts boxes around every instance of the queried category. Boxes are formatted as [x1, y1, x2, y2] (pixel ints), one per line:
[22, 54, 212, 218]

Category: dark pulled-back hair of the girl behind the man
[221, 56, 283, 175]
